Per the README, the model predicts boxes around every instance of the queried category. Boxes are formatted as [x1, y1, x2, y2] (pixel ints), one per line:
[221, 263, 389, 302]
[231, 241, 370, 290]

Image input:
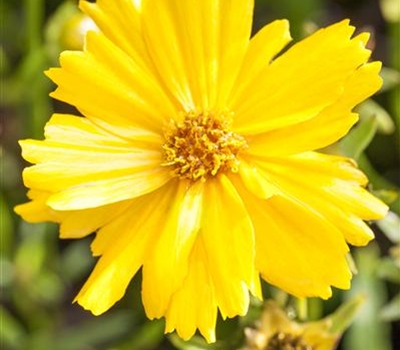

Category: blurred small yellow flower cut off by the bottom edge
[242, 296, 365, 350]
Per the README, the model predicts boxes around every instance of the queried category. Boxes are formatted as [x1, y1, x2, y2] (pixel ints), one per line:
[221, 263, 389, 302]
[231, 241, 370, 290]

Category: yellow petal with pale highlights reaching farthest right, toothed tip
[253, 152, 387, 245]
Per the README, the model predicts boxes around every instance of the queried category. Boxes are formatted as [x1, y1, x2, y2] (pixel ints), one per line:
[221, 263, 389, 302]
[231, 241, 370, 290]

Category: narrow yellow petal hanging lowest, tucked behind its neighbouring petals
[165, 237, 217, 343]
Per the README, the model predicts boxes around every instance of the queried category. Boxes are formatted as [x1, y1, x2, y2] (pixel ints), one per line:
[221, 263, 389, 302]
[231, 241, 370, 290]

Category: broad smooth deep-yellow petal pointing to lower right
[241, 192, 351, 298]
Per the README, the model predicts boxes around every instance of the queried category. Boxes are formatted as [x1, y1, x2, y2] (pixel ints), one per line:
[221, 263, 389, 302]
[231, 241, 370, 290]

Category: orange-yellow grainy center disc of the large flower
[162, 112, 247, 181]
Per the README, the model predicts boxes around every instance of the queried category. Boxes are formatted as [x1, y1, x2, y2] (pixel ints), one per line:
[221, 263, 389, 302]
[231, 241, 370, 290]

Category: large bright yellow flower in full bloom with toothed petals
[16, 0, 386, 342]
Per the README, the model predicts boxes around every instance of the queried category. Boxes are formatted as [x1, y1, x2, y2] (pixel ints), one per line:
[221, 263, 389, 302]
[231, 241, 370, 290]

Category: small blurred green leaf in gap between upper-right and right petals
[339, 115, 378, 160]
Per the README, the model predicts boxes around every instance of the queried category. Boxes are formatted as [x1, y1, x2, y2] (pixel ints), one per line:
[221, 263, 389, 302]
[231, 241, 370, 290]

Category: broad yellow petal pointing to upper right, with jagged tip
[231, 21, 370, 134]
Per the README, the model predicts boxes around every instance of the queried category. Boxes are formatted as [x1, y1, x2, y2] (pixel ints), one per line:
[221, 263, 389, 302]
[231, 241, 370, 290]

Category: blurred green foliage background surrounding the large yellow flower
[0, 0, 400, 350]
